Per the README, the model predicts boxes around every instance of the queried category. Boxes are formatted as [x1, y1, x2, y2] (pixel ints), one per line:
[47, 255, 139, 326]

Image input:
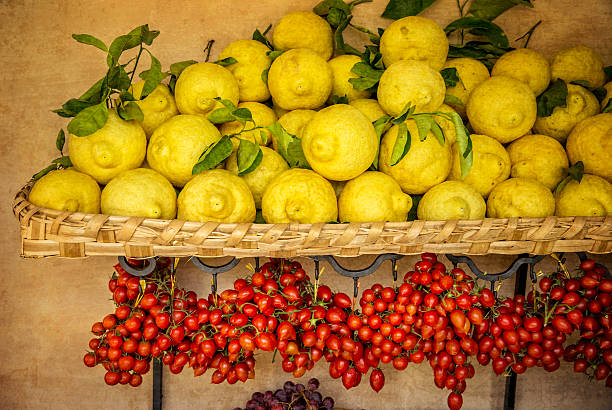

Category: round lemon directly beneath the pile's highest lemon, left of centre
[268, 48, 333, 110]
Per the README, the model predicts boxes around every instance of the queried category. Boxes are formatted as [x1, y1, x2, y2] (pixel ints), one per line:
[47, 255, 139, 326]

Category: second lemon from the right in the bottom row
[487, 178, 555, 218]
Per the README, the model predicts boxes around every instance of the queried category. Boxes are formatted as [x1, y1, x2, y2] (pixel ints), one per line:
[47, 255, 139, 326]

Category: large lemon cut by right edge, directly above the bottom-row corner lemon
[566, 113, 612, 182]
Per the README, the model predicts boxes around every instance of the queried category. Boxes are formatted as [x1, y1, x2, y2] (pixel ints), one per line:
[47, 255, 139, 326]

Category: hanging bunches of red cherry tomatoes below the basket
[84, 254, 612, 409]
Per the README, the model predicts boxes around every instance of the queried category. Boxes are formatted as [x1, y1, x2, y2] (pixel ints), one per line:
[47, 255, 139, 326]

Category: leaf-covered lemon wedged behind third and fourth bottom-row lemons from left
[225, 147, 289, 209]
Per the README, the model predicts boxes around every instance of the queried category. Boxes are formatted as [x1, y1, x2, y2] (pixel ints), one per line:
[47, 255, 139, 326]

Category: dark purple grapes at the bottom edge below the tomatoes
[234, 378, 334, 410]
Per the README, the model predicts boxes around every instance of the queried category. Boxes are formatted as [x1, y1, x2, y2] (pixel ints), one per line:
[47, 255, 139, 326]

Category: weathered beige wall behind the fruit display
[0, 0, 612, 409]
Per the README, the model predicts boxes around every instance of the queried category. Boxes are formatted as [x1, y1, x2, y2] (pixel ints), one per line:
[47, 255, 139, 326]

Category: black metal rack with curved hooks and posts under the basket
[119, 252, 610, 410]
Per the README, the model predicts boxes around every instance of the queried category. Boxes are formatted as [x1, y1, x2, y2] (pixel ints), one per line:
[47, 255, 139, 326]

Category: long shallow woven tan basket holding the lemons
[13, 184, 612, 258]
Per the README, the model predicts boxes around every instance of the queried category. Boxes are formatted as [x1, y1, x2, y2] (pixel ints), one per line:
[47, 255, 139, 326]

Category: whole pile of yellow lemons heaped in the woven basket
[29, 11, 612, 223]
